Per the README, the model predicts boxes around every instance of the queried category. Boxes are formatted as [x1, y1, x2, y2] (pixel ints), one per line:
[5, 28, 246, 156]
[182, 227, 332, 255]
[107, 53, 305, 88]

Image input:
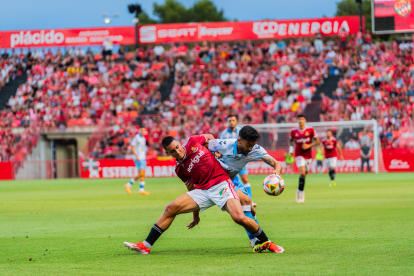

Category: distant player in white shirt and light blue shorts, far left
[125, 127, 150, 195]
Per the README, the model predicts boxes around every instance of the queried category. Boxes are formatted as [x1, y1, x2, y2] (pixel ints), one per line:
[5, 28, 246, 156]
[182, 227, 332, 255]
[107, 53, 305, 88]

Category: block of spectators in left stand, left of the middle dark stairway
[0, 47, 169, 161]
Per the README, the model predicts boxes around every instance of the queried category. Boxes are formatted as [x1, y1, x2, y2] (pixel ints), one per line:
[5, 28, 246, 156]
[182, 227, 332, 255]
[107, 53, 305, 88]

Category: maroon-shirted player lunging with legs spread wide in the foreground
[124, 134, 284, 254]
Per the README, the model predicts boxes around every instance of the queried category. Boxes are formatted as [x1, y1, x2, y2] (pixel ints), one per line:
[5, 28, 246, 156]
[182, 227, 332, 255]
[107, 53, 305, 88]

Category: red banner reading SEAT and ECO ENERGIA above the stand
[139, 16, 359, 43]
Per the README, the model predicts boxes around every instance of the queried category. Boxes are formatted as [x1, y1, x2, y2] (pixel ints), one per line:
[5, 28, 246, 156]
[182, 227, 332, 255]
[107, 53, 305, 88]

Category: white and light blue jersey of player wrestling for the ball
[208, 139, 270, 177]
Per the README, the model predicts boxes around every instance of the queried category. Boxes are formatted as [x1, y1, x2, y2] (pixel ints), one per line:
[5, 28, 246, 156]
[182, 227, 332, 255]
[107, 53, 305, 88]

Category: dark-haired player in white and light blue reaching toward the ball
[208, 126, 282, 248]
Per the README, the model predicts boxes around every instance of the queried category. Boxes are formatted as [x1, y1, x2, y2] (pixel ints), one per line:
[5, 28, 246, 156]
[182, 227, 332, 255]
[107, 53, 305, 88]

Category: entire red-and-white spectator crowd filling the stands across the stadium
[0, 31, 414, 160]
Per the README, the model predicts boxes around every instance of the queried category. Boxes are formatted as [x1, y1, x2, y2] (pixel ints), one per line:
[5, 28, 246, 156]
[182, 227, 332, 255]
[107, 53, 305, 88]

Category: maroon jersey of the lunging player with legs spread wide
[175, 135, 231, 190]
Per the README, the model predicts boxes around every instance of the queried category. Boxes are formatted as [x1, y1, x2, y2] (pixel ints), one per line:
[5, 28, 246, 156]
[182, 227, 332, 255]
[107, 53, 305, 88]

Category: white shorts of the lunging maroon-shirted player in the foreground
[187, 180, 240, 212]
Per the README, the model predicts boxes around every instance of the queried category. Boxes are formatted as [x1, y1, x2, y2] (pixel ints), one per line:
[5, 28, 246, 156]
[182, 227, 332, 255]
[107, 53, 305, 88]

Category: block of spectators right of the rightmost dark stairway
[321, 38, 414, 148]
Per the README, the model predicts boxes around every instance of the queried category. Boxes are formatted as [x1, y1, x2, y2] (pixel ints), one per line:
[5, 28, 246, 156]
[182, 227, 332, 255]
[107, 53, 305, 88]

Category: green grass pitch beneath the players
[0, 173, 414, 275]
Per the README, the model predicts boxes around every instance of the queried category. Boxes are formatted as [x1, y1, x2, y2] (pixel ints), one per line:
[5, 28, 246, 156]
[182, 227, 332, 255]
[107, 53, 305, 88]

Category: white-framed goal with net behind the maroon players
[247, 120, 386, 174]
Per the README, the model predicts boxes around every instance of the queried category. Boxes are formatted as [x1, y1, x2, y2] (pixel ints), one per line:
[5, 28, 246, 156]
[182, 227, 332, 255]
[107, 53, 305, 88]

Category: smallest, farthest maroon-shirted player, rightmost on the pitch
[321, 129, 344, 187]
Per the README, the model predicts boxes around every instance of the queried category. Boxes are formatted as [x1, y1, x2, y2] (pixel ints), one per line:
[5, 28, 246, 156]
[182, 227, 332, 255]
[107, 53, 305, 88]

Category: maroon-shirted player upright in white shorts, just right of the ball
[289, 114, 320, 203]
